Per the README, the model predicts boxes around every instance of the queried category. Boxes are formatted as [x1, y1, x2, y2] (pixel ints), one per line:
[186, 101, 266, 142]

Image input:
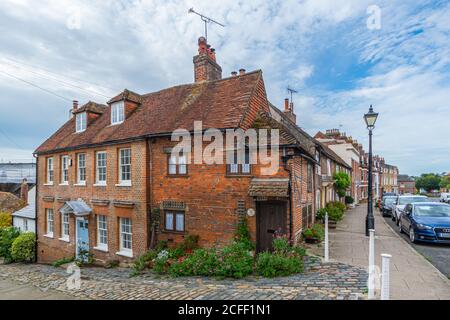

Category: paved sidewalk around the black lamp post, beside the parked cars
[330, 204, 450, 300]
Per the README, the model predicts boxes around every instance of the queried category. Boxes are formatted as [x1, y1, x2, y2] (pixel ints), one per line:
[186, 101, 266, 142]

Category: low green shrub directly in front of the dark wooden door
[256, 252, 303, 278]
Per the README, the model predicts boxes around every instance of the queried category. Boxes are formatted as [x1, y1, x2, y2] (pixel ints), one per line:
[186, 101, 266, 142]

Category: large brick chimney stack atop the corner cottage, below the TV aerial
[194, 37, 222, 82]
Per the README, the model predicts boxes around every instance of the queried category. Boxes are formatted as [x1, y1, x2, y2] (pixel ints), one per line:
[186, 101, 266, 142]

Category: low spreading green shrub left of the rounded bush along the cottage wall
[169, 249, 219, 276]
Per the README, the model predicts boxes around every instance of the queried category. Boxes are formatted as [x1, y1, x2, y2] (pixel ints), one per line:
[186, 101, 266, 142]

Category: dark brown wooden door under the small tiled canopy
[256, 201, 287, 252]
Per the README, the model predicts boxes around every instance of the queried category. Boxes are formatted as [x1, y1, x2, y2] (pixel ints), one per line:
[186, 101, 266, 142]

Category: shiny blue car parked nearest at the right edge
[399, 202, 450, 244]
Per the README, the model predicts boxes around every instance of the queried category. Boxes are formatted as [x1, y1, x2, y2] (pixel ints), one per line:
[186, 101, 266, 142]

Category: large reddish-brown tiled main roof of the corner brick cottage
[35, 70, 262, 154]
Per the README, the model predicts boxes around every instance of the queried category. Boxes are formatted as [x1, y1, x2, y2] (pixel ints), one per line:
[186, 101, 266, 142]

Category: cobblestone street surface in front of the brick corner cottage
[0, 262, 367, 300]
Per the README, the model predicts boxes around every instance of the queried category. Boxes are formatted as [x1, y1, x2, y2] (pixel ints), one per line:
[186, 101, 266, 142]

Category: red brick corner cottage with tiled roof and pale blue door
[35, 38, 317, 262]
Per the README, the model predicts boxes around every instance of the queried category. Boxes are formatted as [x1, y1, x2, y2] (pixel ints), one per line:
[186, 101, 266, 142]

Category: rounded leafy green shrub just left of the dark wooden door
[216, 242, 254, 279]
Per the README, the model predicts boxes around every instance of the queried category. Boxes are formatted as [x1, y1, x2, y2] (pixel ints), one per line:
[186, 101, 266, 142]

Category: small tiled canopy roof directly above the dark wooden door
[248, 178, 289, 197]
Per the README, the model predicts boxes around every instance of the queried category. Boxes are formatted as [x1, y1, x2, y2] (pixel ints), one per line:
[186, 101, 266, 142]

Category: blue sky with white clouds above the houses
[0, 0, 450, 175]
